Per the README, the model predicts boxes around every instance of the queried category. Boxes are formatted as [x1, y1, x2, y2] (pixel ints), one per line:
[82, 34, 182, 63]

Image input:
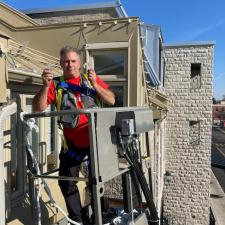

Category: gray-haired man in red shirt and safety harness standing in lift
[33, 46, 115, 223]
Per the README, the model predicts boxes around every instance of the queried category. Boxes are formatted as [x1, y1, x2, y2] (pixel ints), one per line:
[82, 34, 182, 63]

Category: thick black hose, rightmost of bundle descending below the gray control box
[124, 148, 159, 225]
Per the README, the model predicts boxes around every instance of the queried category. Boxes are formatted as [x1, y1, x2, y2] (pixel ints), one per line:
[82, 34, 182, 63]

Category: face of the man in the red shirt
[60, 51, 81, 79]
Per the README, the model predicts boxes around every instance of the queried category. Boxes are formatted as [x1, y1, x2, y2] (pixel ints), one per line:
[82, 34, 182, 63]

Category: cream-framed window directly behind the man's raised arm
[86, 42, 128, 107]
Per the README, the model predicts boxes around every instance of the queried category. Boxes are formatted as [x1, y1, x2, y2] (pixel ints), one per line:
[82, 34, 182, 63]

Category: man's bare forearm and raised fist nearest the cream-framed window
[88, 70, 115, 106]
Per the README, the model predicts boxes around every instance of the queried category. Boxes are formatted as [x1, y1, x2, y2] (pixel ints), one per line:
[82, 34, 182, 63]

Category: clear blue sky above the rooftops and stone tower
[3, 0, 225, 99]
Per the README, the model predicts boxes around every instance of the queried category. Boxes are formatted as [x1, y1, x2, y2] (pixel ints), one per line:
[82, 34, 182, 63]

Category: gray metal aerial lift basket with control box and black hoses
[22, 106, 159, 225]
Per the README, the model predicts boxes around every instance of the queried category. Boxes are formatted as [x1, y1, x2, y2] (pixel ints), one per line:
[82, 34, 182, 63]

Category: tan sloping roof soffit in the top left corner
[0, 2, 38, 27]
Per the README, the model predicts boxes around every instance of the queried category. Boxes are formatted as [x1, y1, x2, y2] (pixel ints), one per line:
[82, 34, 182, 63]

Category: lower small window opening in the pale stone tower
[189, 121, 200, 145]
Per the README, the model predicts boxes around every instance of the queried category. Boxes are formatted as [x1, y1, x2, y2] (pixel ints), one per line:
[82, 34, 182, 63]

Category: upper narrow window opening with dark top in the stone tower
[190, 63, 201, 89]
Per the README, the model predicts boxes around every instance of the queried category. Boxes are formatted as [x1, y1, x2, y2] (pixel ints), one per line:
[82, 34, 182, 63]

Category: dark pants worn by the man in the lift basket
[59, 143, 90, 222]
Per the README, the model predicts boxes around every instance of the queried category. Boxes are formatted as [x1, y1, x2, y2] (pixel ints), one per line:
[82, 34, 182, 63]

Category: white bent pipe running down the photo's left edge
[0, 102, 17, 224]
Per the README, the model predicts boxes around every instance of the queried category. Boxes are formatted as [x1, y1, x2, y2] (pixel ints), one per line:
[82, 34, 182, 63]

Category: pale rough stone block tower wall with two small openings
[163, 44, 214, 225]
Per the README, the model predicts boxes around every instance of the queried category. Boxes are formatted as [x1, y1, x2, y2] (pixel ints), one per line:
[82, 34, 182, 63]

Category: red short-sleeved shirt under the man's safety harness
[47, 76, 109, 148]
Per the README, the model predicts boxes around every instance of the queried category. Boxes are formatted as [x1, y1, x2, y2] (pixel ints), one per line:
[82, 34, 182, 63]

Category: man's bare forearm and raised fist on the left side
[32, 69, 53, 112]
